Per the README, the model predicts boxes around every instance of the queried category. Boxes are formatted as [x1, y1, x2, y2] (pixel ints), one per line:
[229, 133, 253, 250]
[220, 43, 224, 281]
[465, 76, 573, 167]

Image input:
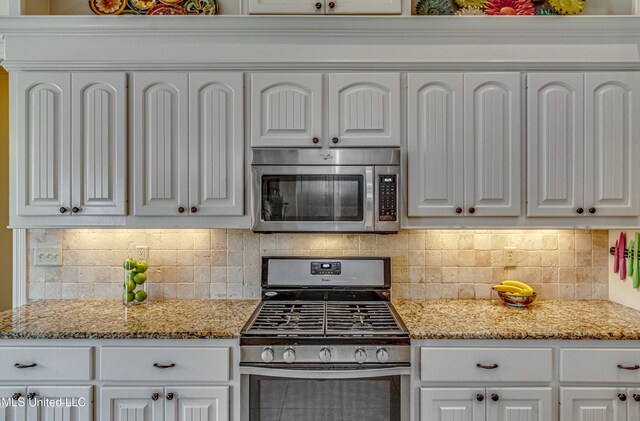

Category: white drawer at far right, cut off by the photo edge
[560, 348, 640, 384]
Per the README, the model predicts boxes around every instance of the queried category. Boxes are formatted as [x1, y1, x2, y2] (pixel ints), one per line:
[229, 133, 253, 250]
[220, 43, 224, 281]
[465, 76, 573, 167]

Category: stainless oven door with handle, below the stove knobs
[241, 367, 410, 421]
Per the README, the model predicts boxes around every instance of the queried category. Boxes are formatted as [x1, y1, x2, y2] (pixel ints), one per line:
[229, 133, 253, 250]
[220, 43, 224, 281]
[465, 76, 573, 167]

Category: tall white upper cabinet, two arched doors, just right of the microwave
[408, 73, 521, 216]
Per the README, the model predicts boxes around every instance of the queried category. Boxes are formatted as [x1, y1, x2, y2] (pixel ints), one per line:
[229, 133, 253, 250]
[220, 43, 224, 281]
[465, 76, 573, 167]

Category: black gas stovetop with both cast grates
[242, 300, 407, 338]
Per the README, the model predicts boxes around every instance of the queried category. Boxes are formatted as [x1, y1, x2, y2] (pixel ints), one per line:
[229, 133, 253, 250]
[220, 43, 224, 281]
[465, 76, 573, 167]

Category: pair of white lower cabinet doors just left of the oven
[99, 386, 229, 421]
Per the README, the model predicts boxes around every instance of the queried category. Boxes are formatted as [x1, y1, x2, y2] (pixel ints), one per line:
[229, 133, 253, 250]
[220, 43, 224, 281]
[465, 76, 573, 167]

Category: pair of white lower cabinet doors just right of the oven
[420, 387, 553, 421]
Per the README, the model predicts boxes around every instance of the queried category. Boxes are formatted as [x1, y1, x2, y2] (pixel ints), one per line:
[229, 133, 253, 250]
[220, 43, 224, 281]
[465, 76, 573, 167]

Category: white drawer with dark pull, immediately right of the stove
[420, 348, 552, 383]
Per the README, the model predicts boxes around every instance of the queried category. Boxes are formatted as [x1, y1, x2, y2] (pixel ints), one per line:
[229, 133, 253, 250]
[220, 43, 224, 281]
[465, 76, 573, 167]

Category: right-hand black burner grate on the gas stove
[326, 301, 402, 336]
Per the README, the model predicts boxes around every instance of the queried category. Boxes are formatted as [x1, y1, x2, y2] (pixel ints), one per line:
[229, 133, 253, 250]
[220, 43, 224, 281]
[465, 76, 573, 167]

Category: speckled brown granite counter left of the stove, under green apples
[0, 300, 259, 339]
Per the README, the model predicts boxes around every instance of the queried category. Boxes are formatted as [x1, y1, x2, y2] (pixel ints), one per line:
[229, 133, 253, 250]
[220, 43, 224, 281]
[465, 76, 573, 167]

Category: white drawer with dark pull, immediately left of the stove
[100, 347, 229, 382]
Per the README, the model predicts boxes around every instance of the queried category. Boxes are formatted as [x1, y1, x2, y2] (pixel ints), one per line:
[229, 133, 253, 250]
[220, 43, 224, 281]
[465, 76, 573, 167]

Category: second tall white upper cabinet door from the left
[71, 72, 127, 215]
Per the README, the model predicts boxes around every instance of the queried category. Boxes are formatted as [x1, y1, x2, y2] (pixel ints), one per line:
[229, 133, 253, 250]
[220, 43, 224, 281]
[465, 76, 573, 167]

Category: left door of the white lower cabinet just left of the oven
[98, 387, 164, 421]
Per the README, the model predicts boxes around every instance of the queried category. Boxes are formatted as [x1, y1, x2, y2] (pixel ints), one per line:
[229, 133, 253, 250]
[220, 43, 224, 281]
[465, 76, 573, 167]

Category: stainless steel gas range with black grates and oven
[240, 257, 411, 421]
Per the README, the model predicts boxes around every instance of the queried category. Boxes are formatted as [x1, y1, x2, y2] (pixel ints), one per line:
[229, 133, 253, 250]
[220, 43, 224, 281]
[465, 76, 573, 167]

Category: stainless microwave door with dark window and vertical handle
[252, 165, 375, 232]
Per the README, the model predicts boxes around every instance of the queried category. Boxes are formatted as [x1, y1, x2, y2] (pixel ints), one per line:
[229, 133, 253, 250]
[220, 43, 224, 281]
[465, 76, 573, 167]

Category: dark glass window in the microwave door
[262, 175, 364, 222]
